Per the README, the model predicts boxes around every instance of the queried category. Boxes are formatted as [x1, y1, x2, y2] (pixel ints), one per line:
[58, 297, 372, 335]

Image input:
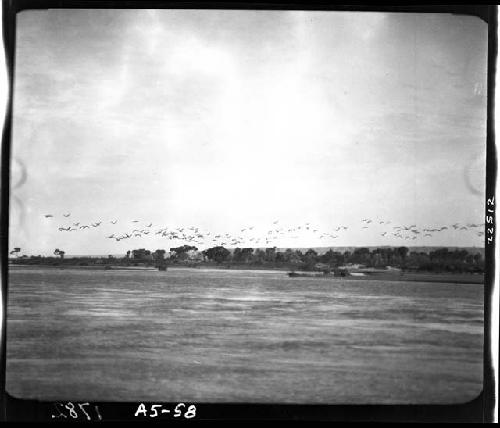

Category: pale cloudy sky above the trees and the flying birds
[10, 9, 487, 254]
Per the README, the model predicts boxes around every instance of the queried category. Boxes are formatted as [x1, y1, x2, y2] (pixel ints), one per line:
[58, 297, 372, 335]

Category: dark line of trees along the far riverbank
[11, 245, 484, 273]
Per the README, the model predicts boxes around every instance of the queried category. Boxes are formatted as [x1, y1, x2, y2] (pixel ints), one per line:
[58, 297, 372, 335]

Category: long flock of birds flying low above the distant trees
[45, 213, 484, 247]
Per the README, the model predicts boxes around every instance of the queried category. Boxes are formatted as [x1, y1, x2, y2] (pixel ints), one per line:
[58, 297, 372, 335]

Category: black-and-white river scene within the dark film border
[1, 4, 488, 418]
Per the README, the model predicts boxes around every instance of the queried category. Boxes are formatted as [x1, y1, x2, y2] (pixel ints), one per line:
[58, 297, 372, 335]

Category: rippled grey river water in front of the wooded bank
[7, 268, 484, 404]
